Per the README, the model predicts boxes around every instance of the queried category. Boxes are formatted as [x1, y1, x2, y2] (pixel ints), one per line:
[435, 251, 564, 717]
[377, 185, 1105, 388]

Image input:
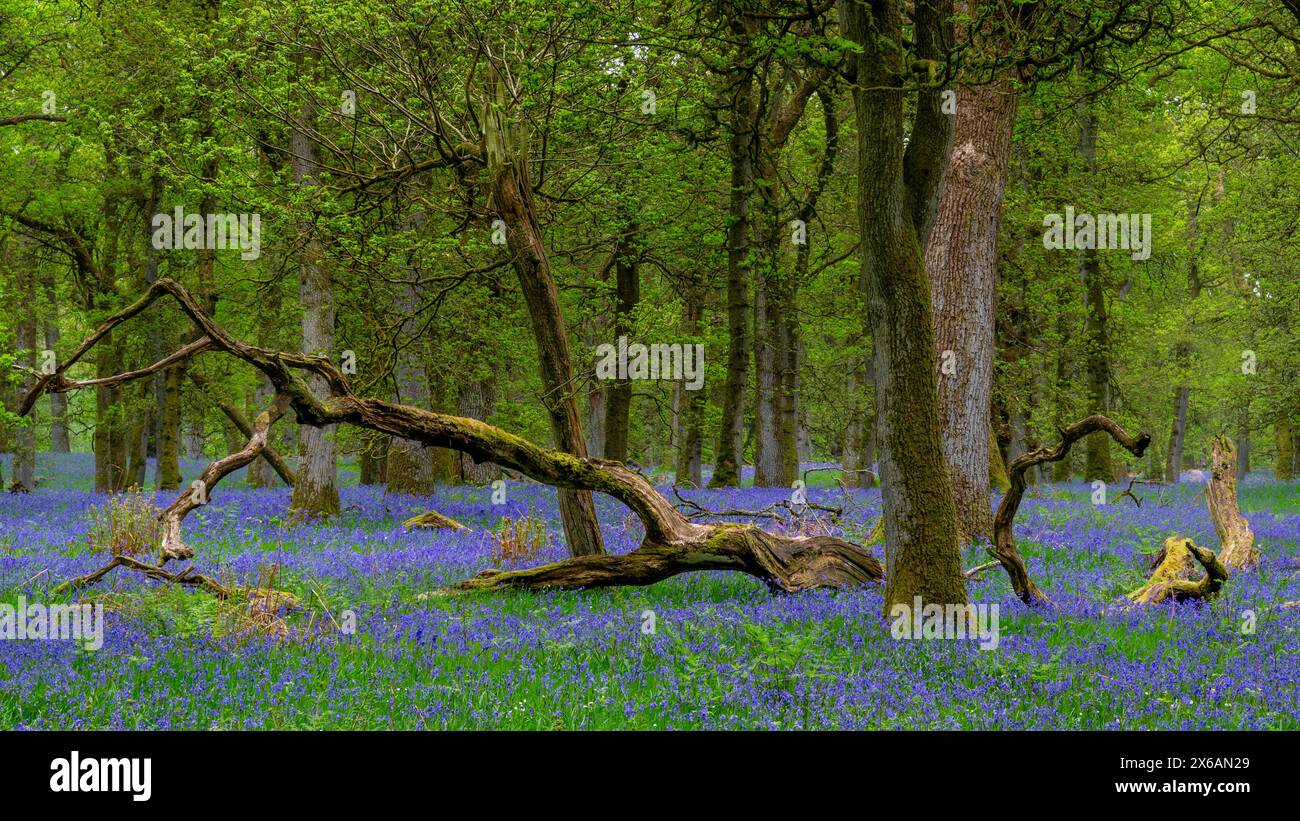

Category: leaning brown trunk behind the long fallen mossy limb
[482, 68, 605, 556]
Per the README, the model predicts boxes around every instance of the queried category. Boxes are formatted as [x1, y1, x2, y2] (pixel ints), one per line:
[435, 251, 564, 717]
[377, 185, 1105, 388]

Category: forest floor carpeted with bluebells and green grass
[0, 453, 1300, 729]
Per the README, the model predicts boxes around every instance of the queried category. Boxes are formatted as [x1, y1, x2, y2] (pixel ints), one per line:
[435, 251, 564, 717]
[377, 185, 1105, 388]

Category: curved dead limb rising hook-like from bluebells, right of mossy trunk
[988, 414, 1151, 605]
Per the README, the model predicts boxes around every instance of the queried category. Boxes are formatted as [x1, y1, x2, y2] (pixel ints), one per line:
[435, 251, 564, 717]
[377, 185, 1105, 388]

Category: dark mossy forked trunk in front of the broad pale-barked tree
[840, 1, 967, 613]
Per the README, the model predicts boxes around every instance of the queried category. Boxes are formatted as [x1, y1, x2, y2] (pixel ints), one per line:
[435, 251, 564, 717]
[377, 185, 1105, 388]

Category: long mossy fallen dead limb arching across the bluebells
[20, 279, 884, 592]
